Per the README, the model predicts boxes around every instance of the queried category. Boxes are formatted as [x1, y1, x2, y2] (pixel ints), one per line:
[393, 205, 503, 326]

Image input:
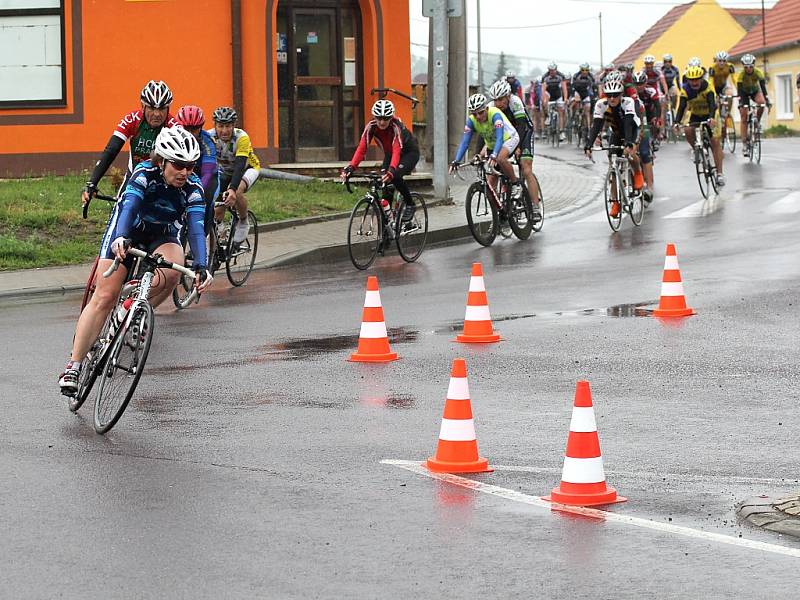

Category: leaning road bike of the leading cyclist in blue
[69, 247, 194, 434]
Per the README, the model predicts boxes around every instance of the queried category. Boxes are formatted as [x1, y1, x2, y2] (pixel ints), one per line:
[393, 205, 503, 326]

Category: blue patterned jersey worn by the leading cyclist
[115, 160, 208, 268]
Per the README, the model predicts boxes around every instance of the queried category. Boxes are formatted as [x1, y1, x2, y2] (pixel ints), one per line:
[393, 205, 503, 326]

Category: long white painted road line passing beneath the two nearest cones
[381, 460, 800, 558]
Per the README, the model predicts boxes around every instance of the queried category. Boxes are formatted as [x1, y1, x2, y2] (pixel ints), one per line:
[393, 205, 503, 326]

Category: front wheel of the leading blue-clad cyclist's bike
[94, 302, 155, 433]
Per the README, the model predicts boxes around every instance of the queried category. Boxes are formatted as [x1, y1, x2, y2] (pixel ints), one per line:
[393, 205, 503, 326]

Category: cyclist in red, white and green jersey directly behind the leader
[81, 79, 175, 204]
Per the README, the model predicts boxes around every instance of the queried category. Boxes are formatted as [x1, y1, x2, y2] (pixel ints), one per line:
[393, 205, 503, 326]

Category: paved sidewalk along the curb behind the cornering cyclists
[0, 152, 602, 297]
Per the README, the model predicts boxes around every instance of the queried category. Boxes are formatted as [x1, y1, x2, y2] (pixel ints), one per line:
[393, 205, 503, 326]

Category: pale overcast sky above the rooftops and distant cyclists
[410, 0, 776, 75]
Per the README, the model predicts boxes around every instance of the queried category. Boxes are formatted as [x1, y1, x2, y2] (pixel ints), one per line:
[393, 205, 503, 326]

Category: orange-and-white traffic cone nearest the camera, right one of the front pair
[544, 381, 627, 506]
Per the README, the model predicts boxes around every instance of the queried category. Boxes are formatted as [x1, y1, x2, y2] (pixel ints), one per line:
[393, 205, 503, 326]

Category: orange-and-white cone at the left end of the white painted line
[425, 358, 492, 473]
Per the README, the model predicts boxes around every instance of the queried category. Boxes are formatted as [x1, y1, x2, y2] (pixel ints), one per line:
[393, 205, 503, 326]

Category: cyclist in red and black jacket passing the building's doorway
[341, 100, 419, 221]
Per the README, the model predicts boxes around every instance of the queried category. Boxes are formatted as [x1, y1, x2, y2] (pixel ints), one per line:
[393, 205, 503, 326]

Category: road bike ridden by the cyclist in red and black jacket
[344, 172, 428, 271]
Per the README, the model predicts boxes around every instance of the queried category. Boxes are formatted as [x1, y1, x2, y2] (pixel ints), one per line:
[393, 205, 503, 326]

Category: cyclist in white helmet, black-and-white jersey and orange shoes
[583, 78, 644, 217]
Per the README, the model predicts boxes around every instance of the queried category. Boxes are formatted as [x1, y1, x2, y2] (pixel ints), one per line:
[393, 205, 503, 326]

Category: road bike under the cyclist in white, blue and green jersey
[454, 154, 544, 246]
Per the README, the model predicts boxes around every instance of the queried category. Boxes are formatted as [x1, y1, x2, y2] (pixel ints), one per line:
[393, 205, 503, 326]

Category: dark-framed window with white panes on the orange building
[0, 0, 66, 108]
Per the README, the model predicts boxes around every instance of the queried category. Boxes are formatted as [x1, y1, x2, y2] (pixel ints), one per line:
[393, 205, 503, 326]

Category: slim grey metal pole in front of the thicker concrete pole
[430, 0, 449, 198]
